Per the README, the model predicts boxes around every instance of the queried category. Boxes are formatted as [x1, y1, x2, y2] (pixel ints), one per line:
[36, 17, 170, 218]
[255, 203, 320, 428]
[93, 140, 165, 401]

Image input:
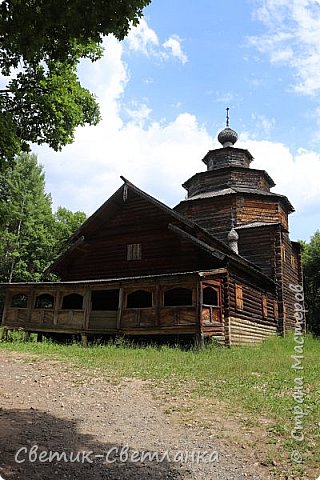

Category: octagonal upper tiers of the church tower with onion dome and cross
[176, 109, 294, 249]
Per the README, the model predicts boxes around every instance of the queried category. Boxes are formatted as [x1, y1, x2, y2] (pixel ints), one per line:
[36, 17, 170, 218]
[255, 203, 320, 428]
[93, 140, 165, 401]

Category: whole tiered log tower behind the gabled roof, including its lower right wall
[175, 109, 302, 330]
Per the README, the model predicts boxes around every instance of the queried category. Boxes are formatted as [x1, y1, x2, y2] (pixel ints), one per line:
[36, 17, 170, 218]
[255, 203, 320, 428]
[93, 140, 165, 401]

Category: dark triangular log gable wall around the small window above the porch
[54, 192, 218, 281]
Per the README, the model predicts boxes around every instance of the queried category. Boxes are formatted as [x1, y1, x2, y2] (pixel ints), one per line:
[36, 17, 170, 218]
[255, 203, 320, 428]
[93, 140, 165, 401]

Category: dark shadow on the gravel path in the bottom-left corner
[0, 409, 181, 480]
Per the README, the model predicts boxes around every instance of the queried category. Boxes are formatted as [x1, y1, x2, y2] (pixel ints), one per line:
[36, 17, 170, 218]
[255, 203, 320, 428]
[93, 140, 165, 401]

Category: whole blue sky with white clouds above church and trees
[29, 0, 320, 240]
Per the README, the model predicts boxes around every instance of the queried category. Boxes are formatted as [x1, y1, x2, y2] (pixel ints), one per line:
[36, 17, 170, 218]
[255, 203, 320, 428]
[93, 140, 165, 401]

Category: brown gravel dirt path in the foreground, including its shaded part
[0, 352, 269, 480]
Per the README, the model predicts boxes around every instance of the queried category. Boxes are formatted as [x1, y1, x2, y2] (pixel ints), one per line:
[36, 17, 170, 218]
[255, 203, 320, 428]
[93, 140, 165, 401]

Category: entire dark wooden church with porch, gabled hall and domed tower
[2, 119, 302, 345]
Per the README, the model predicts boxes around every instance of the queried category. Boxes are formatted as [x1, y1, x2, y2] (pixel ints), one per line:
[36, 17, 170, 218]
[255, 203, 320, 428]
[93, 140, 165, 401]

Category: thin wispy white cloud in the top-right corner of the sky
[249, 0, 320, 95]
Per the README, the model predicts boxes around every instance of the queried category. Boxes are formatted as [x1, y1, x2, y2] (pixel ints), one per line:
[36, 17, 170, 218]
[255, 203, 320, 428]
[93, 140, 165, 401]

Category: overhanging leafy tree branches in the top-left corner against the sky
[0, 0, 150, 168]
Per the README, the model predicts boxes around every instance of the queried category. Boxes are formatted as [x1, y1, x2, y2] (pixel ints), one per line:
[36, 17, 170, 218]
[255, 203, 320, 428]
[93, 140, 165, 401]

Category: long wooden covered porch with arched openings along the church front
[2, 269, 225, 344]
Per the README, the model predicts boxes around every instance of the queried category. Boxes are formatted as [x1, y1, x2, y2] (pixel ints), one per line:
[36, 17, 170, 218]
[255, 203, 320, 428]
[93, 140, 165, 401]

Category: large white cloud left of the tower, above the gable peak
[34, 33, 212, 213]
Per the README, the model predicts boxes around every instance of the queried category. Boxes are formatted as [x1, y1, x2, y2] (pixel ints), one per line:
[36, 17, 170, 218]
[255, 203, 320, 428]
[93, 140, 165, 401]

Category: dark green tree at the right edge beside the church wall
[301, 230, 320, 335]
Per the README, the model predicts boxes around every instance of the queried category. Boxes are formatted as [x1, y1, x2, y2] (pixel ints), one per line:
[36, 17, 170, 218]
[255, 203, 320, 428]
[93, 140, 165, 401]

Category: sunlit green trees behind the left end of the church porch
[0, 153, 86, 282]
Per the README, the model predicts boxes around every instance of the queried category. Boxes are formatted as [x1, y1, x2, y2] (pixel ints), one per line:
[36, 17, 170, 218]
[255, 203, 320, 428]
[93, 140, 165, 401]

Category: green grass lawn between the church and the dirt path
[0, 334, 320, 479]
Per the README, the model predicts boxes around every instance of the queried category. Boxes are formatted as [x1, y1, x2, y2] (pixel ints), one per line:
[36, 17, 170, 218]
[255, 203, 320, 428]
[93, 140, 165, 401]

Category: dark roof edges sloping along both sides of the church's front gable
[47, 177, 272, 282]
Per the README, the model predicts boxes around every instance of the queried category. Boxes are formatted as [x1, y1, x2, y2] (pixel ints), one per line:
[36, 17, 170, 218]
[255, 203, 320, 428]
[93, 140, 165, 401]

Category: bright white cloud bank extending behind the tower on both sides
[34, 30, 320, 240]
